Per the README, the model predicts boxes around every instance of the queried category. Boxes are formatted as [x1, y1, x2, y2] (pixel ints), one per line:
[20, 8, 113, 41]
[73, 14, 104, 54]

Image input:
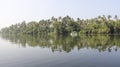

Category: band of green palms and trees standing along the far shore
[0, 15, 120, 36]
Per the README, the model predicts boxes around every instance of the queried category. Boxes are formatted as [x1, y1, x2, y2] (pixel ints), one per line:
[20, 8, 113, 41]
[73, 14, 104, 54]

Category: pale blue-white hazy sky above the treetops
[0, 0, 120, 29]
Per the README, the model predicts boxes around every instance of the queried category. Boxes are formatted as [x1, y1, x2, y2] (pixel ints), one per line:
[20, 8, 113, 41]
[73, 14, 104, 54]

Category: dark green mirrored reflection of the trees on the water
[1, 35, 120, 52]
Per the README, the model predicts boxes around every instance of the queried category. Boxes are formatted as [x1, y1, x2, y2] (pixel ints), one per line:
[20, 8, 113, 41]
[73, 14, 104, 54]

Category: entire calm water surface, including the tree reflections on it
[0, 35, 120, 67]
